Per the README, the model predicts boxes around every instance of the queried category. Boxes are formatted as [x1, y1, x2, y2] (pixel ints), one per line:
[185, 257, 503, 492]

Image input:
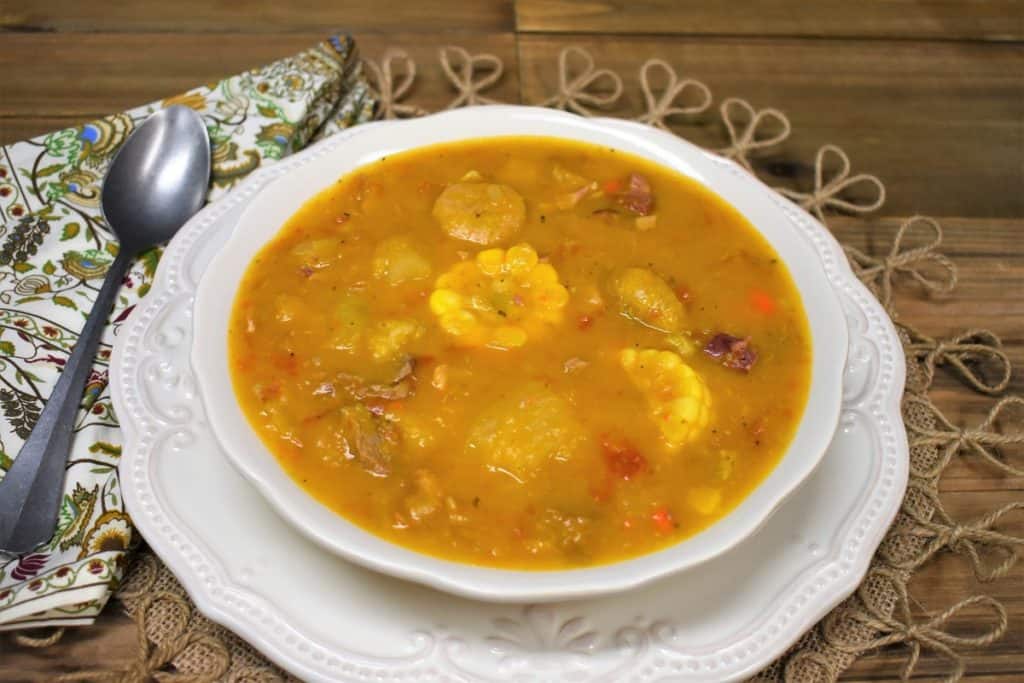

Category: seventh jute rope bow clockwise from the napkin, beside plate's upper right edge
[845, 216, 956, 310]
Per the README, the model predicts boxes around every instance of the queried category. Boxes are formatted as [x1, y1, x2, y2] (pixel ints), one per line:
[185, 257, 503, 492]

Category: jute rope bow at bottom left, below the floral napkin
[54, 591, 230, 683]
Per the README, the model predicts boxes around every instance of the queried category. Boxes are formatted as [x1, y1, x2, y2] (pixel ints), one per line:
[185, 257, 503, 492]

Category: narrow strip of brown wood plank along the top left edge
[0, 0, 515, 33]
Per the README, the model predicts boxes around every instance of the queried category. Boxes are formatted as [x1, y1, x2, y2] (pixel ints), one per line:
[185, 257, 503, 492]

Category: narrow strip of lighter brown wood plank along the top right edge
[515, 0, 1024, 40]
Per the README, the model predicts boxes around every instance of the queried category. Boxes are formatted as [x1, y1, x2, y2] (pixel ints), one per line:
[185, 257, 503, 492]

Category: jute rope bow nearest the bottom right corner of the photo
[824, 569, 1008, 683]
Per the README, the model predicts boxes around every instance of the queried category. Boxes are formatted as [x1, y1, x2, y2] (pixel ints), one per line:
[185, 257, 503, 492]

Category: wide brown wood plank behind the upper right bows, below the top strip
[519, 35, 1024, 218]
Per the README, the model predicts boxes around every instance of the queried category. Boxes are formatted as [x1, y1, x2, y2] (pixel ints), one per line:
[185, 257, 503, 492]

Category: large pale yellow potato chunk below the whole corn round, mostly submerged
[466, 383, 586, 483]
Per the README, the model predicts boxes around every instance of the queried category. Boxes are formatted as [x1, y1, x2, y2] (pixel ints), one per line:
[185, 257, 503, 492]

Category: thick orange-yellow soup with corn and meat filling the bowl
[228, 137, 812, 569]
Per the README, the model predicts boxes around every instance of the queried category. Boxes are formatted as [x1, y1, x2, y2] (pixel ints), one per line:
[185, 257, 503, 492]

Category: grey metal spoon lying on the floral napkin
[0, 105, 210, 554]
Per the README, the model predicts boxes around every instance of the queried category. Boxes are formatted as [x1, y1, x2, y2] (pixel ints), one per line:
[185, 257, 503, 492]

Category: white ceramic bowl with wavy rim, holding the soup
[193, 106, 848, 602]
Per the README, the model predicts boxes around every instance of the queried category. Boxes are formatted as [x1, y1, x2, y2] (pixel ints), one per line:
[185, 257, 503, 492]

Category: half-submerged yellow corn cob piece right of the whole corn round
[618, 348, 711, 451]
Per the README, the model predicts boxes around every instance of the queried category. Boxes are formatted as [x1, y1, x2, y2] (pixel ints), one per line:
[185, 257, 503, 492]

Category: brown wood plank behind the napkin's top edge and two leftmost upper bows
[0, 33, 519, 143]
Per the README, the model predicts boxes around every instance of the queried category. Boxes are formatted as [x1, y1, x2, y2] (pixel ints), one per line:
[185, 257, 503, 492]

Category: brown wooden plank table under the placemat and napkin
[0, 0, 1024, 682]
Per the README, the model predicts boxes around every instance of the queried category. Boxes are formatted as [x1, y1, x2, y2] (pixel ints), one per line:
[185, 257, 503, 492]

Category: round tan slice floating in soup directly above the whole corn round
[433, 182, 526, 246]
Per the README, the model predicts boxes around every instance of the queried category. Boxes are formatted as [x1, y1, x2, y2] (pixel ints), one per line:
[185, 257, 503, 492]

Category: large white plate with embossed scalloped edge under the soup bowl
[111, 117, 908, 681]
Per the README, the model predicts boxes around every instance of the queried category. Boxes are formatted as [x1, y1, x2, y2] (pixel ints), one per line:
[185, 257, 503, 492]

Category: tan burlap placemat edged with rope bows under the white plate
[9, 46, 1024, 682]
